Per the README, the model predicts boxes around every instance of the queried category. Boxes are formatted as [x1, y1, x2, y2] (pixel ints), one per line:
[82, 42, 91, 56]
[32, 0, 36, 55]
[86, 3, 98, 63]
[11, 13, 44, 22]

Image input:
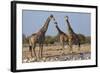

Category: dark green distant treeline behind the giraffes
[22, 34, 91, 45]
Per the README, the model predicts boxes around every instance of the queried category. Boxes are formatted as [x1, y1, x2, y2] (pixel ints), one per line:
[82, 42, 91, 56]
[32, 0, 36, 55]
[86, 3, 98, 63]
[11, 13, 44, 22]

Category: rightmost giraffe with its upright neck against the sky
[65, 16, 80, 51]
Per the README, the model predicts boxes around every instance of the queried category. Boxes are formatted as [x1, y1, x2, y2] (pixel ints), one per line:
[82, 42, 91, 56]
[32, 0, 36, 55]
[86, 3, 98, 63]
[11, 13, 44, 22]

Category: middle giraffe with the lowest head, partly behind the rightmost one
[55, 22, 68, 54]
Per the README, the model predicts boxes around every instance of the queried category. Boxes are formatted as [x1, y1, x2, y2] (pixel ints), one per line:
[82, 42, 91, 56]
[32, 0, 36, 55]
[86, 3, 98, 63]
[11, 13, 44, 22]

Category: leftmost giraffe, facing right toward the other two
[29, 14, 55, 60]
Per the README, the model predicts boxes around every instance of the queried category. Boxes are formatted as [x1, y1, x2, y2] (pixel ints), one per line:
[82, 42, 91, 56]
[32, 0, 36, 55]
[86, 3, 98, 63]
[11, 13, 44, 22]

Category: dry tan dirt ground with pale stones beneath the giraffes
[22, 44, 91, 63]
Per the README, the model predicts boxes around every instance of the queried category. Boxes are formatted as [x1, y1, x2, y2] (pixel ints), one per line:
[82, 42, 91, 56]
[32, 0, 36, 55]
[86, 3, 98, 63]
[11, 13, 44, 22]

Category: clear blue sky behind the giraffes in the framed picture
[22, 10, 91, 36]
